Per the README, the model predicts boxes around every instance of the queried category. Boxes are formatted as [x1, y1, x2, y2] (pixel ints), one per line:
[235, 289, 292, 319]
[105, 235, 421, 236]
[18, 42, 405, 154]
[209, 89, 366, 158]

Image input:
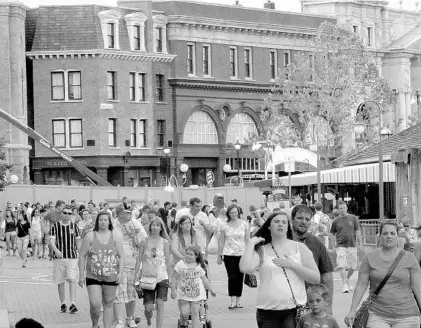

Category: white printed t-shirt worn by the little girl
[174, 260, 206, 302]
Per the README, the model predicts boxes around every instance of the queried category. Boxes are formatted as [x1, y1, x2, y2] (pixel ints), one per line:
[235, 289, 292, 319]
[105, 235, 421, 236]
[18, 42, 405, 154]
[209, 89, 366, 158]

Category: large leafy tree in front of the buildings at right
[262, 22, 395, 159]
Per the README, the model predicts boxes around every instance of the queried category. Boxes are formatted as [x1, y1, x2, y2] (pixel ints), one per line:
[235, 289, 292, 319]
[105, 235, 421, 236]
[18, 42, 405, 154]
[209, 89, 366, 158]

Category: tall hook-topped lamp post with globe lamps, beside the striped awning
[354, 100, 392, 220]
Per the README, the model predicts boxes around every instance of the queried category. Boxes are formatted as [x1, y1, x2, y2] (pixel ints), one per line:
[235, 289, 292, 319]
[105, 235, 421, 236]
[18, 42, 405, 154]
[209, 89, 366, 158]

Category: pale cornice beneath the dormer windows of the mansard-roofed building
[26, 49, 177, 63]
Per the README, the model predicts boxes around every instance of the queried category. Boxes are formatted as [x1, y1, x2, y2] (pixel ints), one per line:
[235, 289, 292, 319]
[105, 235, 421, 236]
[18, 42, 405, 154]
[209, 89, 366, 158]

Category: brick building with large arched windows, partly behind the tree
[153, 0, 335, 185]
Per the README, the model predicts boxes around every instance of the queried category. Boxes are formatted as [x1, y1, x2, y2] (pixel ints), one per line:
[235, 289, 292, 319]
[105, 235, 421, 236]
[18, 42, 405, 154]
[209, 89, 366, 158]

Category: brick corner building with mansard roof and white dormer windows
[26, 2, 175, 186]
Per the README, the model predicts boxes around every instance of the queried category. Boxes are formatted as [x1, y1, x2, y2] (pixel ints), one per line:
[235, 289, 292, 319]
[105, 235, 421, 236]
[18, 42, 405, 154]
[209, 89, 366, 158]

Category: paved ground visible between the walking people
[0, 256, 352, 328]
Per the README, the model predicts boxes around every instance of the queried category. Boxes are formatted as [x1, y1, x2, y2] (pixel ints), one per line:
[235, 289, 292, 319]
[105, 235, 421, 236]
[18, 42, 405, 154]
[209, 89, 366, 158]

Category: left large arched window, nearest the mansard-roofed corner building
[183, 111, 218, 145]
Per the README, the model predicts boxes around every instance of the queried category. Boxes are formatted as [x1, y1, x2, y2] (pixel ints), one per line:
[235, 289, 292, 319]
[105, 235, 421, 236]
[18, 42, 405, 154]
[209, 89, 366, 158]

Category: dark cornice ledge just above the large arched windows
[168, 79, 274, 93]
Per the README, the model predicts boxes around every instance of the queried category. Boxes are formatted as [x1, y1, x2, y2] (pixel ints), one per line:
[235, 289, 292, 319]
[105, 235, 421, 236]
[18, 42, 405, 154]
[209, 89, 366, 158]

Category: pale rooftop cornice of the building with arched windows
[168, 15, 317, 38]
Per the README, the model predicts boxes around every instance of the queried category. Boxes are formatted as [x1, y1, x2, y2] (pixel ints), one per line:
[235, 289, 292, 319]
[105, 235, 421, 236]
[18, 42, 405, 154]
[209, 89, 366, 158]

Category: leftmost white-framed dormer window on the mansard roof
[98, 9, 121, 49]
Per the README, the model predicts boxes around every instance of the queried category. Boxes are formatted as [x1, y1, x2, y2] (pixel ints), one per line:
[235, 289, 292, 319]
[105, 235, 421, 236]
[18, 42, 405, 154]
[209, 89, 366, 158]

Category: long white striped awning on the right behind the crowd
[280, 162, 395, 186]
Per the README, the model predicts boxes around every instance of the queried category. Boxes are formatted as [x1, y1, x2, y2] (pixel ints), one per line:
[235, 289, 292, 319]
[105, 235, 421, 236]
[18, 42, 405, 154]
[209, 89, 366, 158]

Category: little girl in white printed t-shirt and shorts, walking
[171, 246, 215, 328]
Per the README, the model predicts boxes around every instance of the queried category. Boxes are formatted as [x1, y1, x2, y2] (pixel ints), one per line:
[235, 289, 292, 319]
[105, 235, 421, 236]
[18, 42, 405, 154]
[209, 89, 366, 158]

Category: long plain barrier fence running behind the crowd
[0, 185, 262, 213]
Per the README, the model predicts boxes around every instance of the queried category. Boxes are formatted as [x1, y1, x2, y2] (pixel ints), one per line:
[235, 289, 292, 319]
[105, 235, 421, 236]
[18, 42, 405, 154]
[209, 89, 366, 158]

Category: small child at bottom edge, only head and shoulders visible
[297, 284, 339, 328]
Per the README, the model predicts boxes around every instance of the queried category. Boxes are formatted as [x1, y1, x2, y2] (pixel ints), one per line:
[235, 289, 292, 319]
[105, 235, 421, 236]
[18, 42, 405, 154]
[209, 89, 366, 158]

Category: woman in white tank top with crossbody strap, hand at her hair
[240, 212, 320, 328]
